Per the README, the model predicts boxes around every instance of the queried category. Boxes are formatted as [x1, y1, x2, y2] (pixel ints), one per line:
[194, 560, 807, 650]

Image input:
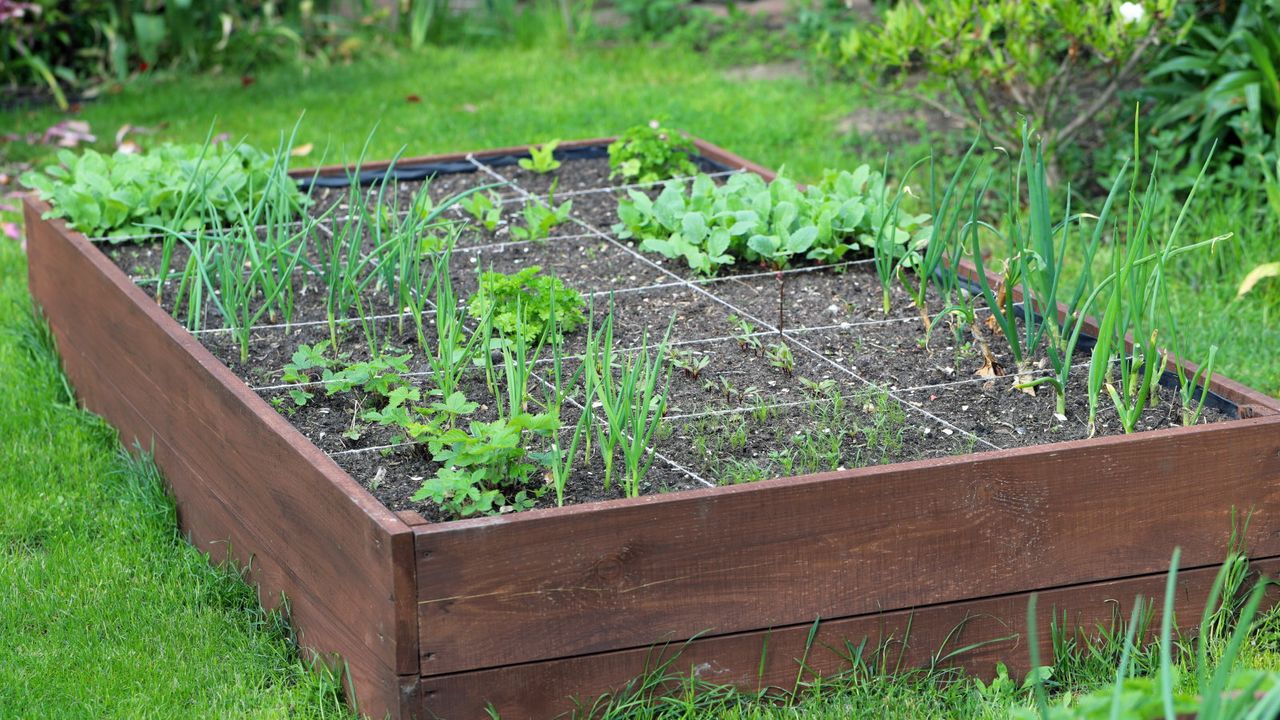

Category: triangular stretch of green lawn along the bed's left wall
[0, 242, 346, 719]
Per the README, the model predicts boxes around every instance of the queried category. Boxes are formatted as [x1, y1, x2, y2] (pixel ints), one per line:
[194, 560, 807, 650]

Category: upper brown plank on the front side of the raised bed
[415, 418, 1280, 675]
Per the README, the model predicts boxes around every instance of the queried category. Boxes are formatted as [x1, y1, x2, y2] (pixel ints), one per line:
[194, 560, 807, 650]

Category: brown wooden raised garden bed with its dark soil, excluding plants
[26, 140, 1280, 717]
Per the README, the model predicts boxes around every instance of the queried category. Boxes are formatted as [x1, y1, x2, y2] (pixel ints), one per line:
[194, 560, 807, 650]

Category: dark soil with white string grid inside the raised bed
[101, 149, 1225, 521]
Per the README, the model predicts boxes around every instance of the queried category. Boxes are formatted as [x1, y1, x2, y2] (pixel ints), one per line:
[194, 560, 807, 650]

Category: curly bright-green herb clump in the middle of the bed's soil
[467, 265, 586, 342]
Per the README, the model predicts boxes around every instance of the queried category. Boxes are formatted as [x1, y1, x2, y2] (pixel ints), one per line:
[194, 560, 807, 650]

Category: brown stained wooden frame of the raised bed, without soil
[24, 141, 1280, 719]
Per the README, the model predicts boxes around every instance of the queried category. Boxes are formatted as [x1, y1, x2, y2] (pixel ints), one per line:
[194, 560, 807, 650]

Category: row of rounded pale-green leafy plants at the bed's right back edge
[613, 165, 929, 275]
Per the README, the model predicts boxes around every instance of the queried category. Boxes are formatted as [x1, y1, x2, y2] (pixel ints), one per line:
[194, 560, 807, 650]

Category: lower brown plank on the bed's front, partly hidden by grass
[422, 557, 1280, 720]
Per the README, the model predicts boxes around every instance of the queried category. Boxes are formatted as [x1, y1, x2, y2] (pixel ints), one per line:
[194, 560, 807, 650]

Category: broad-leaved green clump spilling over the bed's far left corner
[20, 145, 303, 241]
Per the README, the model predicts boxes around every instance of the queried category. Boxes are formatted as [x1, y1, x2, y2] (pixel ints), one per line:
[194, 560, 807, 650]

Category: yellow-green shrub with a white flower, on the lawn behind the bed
[836, 0, 1175, 158]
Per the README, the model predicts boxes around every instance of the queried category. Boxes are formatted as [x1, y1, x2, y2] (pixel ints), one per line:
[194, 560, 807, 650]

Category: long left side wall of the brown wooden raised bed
[26, 197, 419, 715]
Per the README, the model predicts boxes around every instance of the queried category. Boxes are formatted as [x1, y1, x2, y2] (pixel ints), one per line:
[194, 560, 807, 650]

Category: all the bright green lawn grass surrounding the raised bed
[0, 40, 1280, 717]
